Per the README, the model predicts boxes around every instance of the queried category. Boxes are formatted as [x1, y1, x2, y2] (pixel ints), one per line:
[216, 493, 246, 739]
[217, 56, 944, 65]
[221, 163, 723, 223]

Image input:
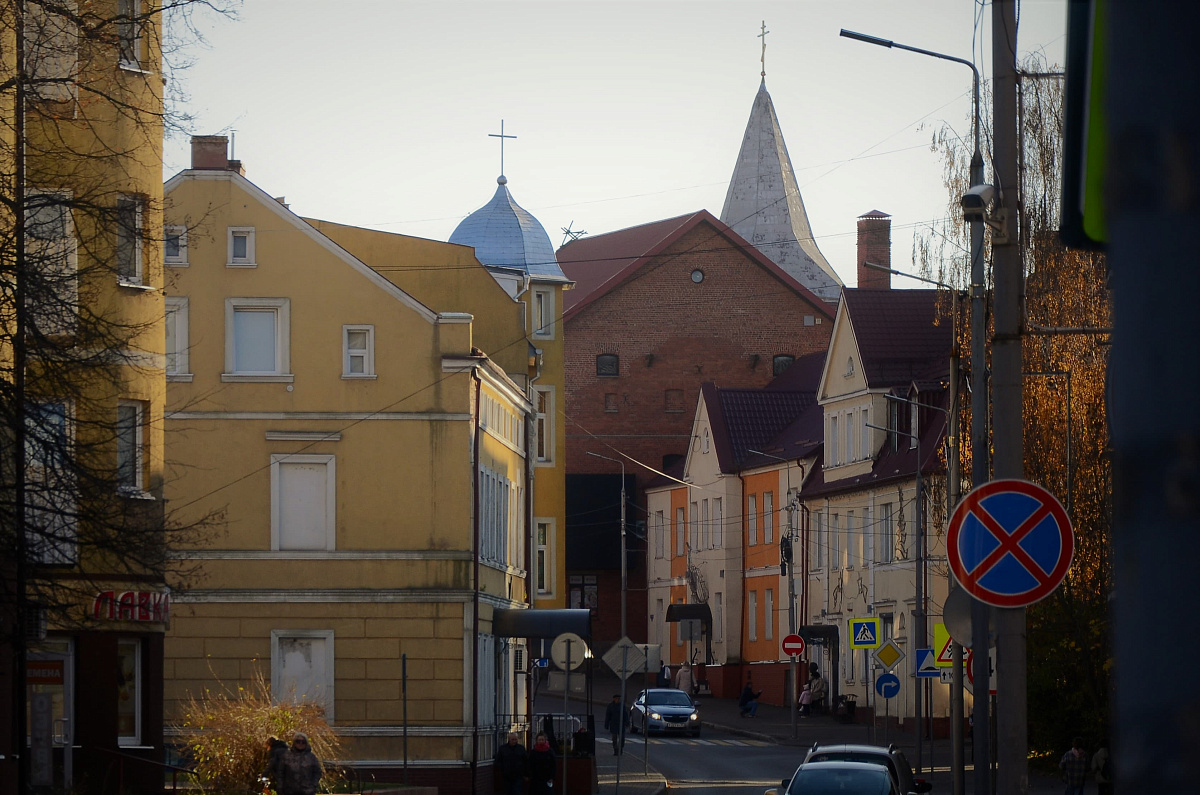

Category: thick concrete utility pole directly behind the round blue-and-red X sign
[976, 0, 1030, 795]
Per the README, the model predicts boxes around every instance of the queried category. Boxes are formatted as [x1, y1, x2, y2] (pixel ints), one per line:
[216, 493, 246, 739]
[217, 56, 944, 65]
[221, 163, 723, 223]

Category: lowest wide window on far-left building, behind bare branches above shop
[25, 402, 77, 566]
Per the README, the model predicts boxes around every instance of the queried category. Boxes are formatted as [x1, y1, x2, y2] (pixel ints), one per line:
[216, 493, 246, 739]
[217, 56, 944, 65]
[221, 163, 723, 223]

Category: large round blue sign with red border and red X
[946, 480, 1075, 608]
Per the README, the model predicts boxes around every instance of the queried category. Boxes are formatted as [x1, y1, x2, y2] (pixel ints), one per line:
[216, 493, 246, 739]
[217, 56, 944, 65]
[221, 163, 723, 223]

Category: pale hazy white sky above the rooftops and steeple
[164, 0, 1067, 287]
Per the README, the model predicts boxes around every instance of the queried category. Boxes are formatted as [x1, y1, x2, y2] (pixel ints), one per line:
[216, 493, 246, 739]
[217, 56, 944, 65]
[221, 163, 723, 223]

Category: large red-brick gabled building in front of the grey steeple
[558, 210, 834, 642]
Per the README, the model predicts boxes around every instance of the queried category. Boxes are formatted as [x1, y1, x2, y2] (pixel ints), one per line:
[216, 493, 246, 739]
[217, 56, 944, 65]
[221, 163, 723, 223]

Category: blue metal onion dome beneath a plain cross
[450, 175, 570, 281]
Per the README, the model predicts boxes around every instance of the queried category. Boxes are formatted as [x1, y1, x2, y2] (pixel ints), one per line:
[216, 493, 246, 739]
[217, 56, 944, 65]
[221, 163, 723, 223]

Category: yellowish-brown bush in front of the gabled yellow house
[181, 674, 342, 793]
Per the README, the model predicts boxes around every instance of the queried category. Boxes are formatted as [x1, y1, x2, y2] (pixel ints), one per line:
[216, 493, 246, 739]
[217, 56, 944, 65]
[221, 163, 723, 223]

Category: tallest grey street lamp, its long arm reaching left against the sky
[841, 29, 991, 795]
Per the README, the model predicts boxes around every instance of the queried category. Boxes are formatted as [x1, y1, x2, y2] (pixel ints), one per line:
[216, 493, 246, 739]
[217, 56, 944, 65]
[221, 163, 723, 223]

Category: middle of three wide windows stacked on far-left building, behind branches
[25, 193, 79, 335]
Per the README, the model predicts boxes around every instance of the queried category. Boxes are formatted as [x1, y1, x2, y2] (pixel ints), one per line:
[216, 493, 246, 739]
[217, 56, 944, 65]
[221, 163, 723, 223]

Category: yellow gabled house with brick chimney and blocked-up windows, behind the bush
[164, 137, 533, 791]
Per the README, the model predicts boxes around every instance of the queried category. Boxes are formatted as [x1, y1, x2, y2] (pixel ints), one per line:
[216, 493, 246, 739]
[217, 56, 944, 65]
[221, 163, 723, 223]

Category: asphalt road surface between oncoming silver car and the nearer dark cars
[596, 727, 799, 795]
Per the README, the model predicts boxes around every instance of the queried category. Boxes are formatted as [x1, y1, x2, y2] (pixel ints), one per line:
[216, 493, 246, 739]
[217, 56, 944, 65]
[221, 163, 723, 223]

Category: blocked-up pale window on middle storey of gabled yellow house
[271, 455, 337, 550]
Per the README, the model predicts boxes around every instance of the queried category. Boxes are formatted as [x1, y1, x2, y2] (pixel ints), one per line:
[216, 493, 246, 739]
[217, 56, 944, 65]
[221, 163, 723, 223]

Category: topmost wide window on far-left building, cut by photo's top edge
[24, 0, 79, 102]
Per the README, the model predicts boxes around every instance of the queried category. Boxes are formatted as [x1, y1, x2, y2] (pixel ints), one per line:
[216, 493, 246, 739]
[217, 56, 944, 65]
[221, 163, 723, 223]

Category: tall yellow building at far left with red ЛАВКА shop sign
[0, 0, 169, 793]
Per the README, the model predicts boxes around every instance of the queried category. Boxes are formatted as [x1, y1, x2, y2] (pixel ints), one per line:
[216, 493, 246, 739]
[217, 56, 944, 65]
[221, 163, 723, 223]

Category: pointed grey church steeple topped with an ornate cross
[721, 81, 842, 303]
